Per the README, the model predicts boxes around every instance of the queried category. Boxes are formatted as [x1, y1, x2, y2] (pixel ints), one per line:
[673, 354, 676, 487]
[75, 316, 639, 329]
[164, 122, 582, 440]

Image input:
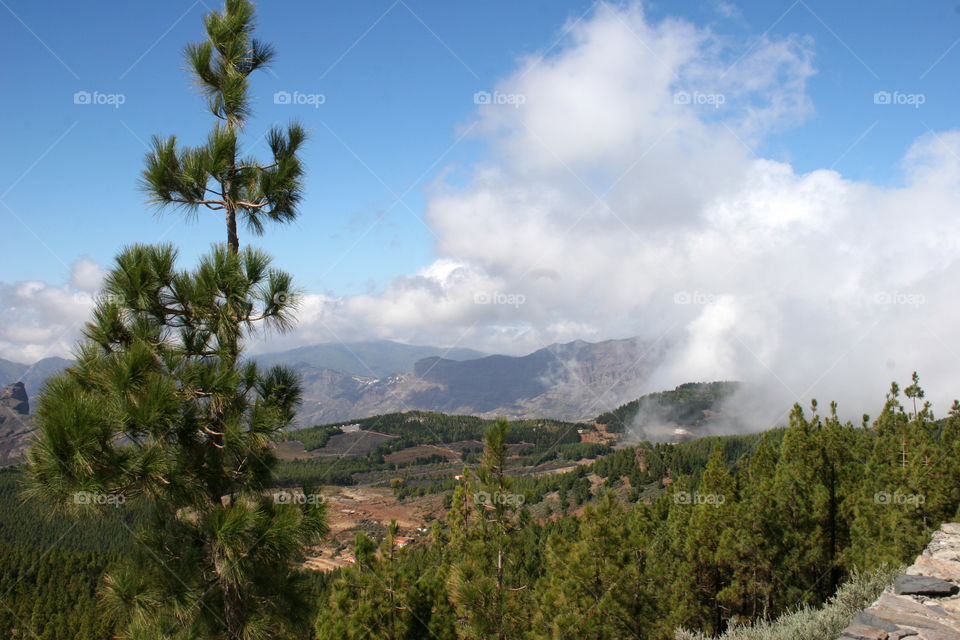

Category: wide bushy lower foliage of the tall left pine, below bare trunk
[27, 245, 325, 637]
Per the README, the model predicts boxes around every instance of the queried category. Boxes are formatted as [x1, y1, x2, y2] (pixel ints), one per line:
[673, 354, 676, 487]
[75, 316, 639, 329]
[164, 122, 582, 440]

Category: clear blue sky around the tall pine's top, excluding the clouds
[0, 0, 960, 295]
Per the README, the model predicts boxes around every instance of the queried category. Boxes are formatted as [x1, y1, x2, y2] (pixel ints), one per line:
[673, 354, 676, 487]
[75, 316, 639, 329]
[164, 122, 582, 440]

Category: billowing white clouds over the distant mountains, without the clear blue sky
[7, 5, 960, 424]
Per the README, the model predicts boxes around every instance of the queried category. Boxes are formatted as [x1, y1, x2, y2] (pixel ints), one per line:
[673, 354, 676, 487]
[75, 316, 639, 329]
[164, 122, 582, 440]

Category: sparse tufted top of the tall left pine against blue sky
[143, 0, 306, 253]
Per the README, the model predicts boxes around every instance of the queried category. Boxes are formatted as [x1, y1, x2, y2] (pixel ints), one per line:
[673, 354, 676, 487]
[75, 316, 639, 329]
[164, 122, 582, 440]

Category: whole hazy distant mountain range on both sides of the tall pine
[0, 338, 665, 462]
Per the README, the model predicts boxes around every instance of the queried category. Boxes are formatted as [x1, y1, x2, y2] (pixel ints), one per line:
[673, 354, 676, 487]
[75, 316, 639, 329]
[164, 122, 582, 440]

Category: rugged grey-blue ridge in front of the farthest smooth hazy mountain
[291, 338, 666, 426]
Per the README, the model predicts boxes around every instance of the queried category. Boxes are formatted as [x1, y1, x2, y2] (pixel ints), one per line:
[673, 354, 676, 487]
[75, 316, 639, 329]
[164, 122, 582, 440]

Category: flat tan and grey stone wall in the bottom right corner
[839, 523, 960, 640]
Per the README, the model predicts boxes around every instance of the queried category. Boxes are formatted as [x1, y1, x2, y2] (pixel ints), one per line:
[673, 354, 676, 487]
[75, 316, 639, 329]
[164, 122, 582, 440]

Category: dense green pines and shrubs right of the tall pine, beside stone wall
[310, 381, 960, 640]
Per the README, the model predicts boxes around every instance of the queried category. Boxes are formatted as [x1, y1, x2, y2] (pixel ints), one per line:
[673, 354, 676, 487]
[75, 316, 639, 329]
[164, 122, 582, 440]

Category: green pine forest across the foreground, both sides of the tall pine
[7, 382, 960, 639]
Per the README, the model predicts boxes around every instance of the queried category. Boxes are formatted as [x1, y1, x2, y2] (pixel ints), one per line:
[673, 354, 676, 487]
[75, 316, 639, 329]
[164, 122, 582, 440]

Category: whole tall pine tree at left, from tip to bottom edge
[21, 0, 327, 640]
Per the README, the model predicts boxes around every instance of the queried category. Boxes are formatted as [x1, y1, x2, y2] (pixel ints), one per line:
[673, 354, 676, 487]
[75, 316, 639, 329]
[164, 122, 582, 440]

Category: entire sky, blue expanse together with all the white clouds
[0, 0, 960, 416]
